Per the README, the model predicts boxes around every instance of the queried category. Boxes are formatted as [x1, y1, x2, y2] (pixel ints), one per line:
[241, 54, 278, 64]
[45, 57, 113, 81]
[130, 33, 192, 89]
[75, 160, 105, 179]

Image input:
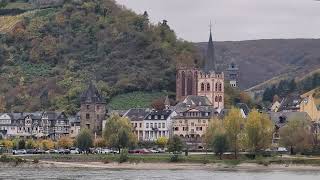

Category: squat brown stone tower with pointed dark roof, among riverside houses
[80, 82, 106, 135]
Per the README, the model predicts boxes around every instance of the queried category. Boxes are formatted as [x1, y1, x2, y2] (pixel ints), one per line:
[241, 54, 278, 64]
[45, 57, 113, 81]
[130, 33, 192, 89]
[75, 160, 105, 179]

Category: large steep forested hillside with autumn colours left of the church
[0, 0, 199, 114]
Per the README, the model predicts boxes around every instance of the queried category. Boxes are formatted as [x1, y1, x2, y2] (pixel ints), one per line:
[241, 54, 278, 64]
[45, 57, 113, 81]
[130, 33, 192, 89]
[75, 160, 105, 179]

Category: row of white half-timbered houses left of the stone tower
[0, 112, 71, 139]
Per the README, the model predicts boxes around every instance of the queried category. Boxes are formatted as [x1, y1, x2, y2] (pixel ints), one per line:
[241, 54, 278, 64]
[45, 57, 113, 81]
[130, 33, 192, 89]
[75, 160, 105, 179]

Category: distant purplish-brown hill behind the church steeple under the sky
[196, 39, 320, 89]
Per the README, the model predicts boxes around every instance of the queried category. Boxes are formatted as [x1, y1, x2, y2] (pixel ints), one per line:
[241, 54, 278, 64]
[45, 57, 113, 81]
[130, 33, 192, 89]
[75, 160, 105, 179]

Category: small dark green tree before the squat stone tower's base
[76, 129, 93, 151]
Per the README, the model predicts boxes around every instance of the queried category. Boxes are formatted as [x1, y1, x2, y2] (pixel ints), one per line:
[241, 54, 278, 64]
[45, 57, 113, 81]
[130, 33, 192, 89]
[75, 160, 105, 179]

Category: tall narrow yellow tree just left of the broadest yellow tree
[224, 108, 244, 159]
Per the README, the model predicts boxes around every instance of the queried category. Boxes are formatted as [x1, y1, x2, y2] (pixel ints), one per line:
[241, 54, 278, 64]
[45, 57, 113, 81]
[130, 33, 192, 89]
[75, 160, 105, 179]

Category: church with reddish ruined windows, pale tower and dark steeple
[176, 29, 224, 110]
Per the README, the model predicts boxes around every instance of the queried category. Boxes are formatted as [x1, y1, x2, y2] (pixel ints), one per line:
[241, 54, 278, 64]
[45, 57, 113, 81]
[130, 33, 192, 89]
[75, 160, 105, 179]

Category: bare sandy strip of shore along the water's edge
[0, 161, 320, 172]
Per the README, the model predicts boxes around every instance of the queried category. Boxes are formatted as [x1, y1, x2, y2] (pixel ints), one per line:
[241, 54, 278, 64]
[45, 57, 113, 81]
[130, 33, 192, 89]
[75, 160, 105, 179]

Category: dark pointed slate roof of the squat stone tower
[80, 82, 105, 104]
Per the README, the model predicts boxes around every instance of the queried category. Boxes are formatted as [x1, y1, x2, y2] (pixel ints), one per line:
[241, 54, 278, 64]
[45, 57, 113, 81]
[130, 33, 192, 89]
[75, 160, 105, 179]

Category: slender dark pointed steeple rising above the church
[204, 22, 216, 72]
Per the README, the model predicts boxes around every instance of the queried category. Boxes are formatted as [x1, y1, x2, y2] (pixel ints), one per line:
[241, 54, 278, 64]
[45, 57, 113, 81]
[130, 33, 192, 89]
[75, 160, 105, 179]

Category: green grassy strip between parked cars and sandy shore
[5, 154, 320, 167]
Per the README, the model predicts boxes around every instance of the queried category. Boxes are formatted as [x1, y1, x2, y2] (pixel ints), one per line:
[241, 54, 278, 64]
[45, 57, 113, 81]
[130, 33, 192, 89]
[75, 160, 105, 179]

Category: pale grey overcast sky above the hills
[116, 0, 320, 42]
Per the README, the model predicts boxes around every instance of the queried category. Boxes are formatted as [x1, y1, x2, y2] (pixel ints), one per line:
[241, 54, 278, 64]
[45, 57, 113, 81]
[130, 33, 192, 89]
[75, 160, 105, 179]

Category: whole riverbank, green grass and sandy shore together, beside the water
[0, 154, 320, 171]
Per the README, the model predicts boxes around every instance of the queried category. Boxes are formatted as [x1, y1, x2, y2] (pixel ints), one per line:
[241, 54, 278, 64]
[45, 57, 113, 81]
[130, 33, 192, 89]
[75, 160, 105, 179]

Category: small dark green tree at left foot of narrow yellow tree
[212, 132, 229, 159]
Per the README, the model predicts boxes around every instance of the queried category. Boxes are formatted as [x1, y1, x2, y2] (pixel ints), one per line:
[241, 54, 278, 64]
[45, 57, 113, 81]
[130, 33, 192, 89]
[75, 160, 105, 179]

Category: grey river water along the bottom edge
[0, 168, 320, 180]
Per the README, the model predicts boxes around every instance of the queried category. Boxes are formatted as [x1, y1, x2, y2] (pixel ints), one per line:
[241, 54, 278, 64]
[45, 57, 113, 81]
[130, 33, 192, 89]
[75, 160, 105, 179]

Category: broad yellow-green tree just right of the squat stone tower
[104, 114, 137, 151]
